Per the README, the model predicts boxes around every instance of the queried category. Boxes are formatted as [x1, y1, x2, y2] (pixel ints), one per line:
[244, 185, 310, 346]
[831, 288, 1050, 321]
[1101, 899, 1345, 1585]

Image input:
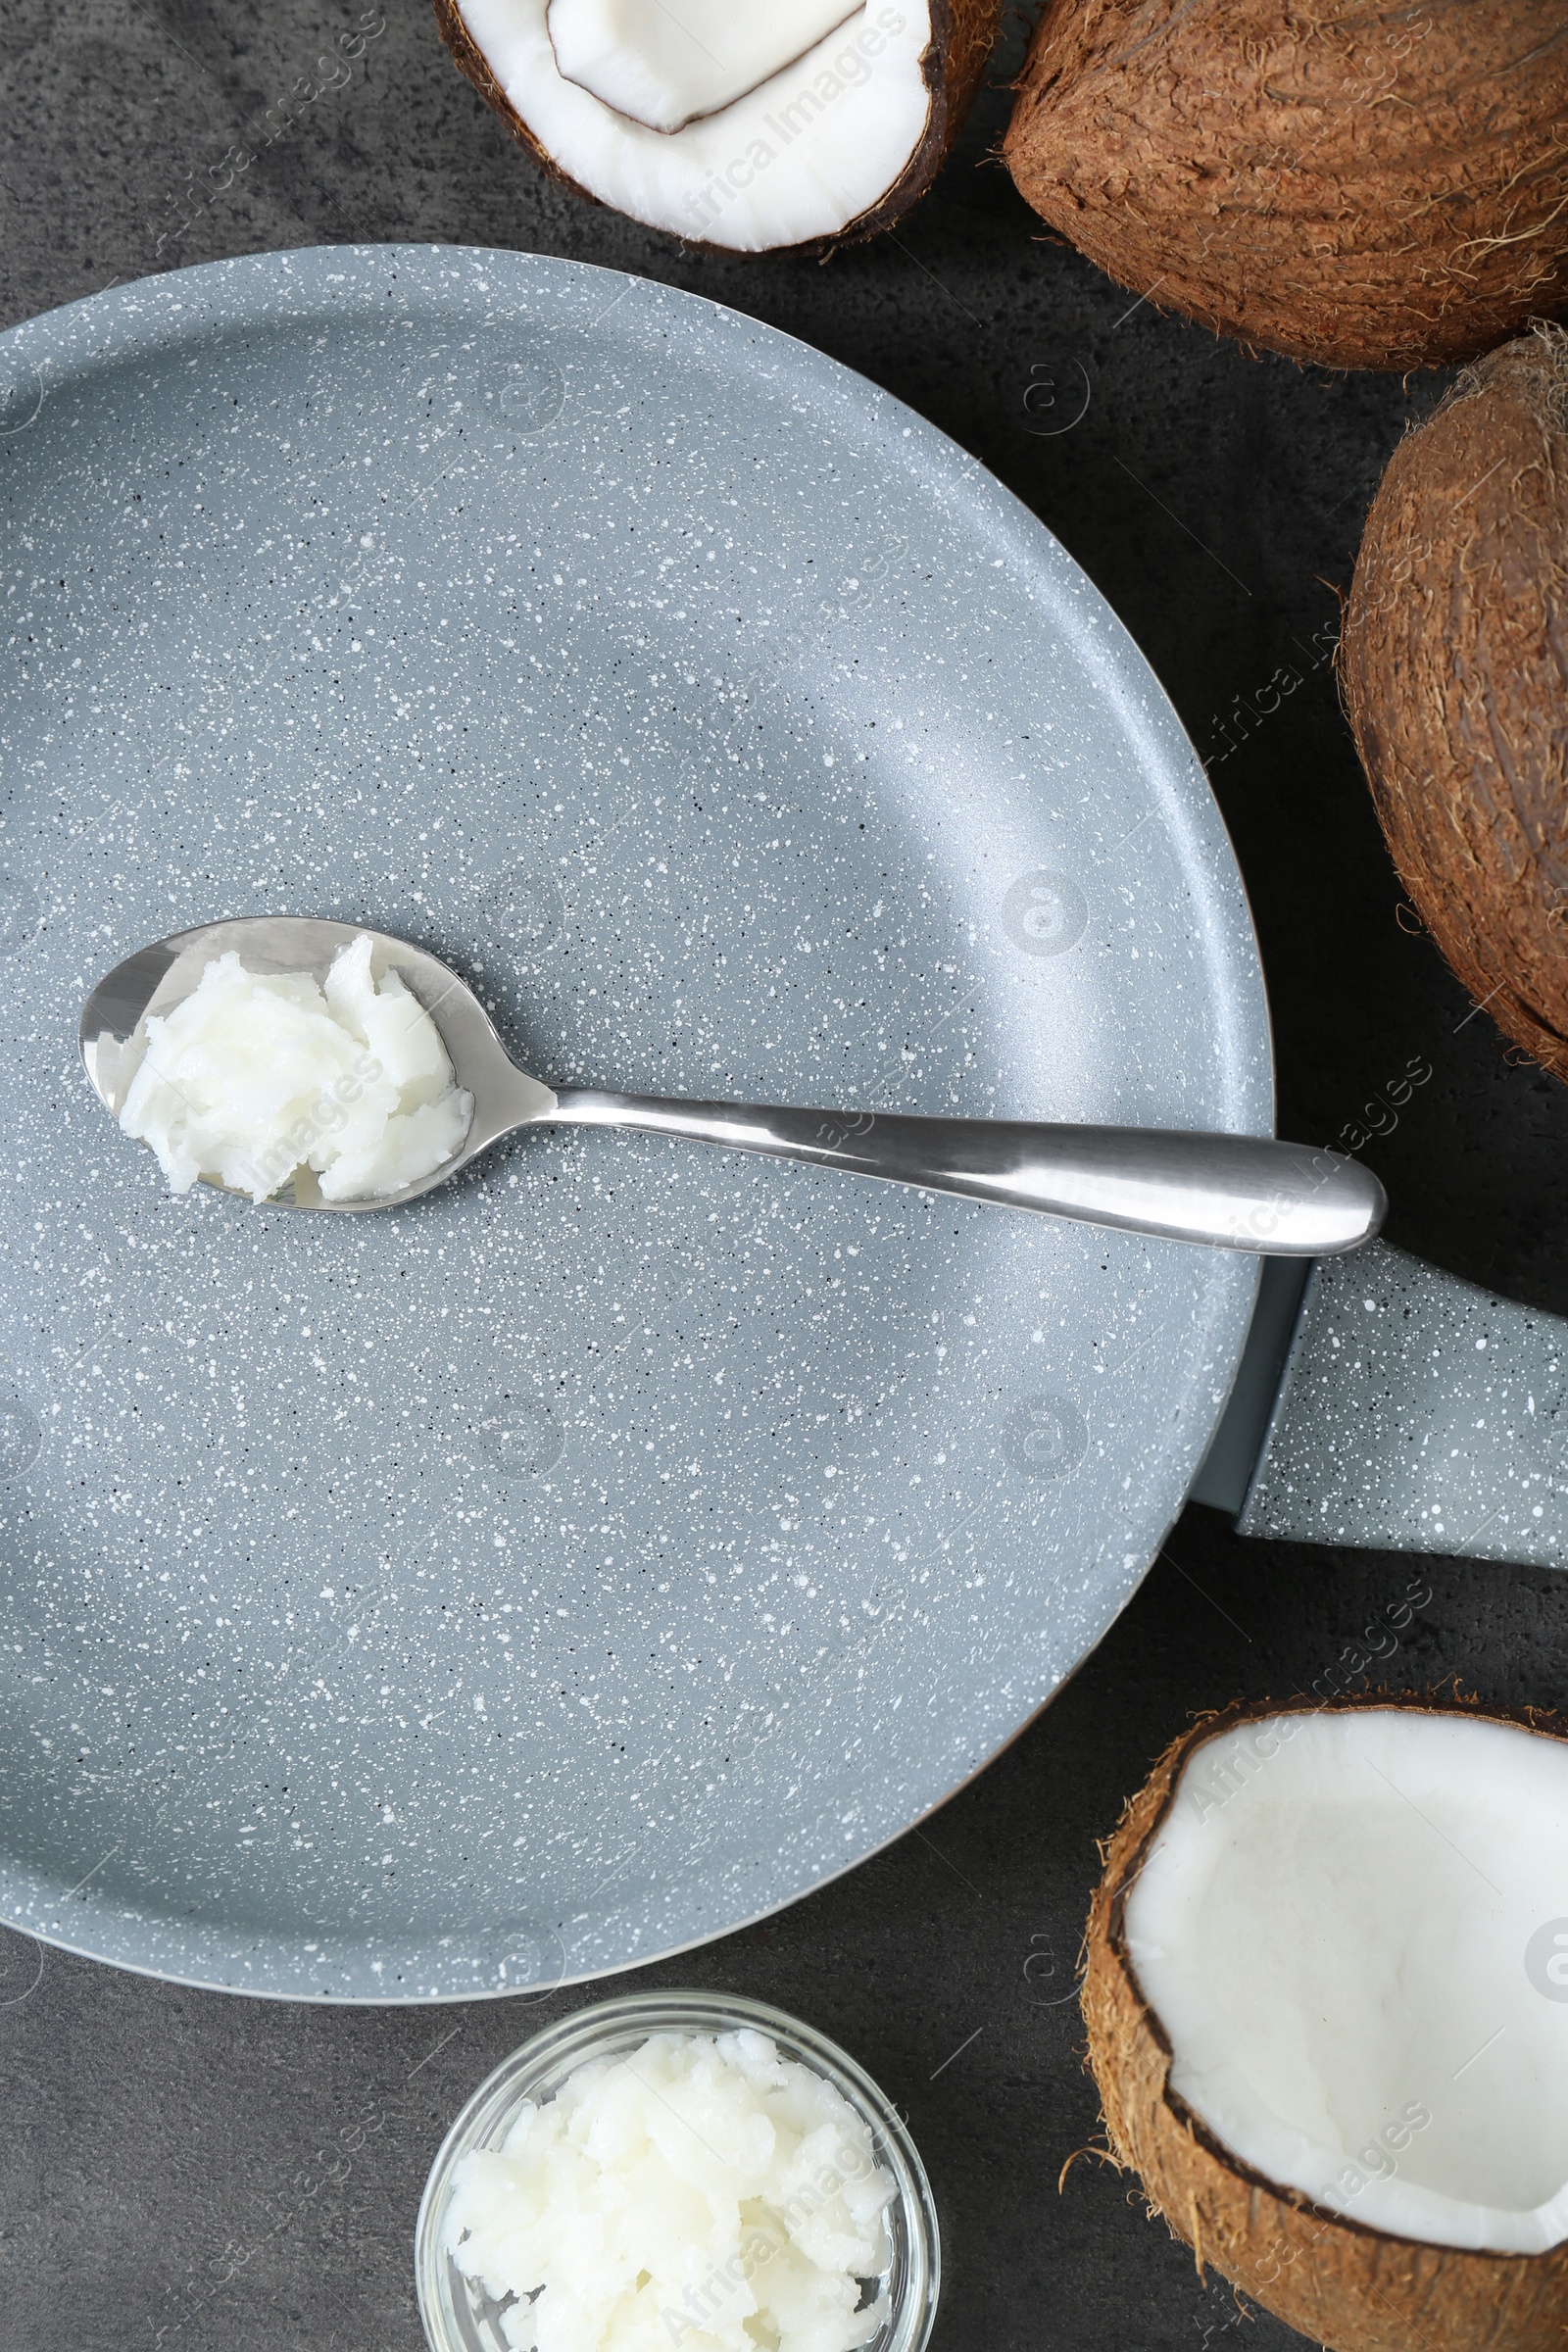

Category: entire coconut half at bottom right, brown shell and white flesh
[1084, 1698, 1568, 2352]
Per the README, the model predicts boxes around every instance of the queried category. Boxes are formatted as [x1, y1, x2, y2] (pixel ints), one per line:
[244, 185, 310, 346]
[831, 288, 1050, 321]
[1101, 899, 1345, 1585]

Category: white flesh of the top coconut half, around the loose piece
[459, 0, 931, 254]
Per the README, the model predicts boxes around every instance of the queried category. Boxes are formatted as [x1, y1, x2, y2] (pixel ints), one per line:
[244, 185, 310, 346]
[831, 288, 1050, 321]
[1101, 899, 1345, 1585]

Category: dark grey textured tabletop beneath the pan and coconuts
[0, 0, 1568, 2352]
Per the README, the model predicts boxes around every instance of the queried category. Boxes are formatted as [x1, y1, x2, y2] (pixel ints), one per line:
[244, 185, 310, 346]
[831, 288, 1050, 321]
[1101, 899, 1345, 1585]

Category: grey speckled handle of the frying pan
[1192, 1242, 1568, 1569]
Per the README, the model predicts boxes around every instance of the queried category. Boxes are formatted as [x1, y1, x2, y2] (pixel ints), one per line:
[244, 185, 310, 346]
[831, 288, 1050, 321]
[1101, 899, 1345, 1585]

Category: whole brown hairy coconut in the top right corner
[1004, 0, 1568, 369]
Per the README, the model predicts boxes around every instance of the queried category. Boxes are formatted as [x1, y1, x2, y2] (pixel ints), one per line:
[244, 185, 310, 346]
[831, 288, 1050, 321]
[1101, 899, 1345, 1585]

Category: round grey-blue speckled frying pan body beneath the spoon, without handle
[0, 247, 1272, 2001]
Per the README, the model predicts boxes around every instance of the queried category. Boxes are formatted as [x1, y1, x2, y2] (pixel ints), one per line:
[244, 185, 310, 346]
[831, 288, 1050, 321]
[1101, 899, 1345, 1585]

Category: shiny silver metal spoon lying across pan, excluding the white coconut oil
[80, 915, 1387, 1258]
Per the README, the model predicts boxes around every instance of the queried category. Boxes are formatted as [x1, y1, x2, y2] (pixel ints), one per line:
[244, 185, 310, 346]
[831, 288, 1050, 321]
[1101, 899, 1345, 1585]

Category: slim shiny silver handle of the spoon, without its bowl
[543, 1087, 1387, 1258]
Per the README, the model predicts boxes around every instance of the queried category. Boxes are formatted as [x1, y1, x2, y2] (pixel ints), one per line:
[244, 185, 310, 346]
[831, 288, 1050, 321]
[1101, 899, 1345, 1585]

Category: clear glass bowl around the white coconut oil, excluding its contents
[414, 1992, 943, 2352]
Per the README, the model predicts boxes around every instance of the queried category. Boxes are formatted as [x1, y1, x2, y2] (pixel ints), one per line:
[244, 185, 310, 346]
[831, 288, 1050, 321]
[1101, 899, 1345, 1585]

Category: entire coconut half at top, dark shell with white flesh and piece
[435, 0, 1002, 254]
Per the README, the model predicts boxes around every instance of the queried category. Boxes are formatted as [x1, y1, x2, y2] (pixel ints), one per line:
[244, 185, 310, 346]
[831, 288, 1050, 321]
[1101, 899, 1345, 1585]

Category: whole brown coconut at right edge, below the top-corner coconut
[1340, 327, 1568, 1080]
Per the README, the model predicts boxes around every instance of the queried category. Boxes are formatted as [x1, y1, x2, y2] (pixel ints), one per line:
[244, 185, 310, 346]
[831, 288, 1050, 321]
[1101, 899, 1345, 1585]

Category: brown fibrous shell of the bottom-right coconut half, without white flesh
[1084, 1693, 1568, 2352]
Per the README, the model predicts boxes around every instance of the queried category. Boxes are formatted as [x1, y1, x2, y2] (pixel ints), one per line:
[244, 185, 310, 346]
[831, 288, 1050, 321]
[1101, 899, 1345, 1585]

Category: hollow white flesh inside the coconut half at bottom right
[1124, 1707, 1568, 2253]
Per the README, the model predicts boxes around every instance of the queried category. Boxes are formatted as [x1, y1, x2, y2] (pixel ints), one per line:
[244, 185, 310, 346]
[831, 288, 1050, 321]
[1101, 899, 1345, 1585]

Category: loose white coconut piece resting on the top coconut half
[546, 0, 858, 131]
